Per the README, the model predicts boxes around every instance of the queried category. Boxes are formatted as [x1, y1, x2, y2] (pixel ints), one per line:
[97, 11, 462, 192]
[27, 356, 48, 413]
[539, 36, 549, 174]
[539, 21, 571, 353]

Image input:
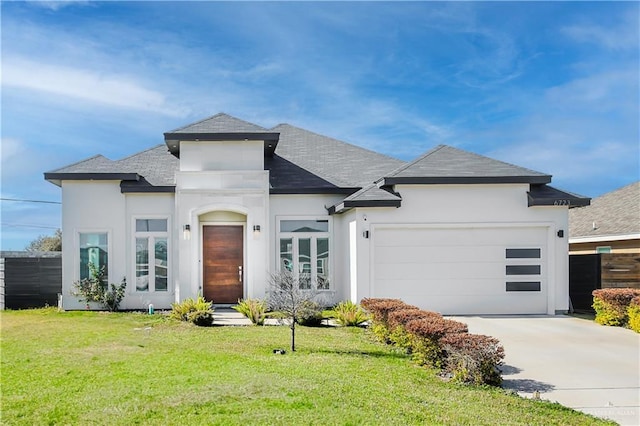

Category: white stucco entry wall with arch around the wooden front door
[175, 168, 270, 302]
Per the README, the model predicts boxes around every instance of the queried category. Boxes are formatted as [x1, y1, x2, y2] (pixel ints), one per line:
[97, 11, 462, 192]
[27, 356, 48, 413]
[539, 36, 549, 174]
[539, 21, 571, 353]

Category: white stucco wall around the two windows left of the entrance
[62, 181, 177, 309]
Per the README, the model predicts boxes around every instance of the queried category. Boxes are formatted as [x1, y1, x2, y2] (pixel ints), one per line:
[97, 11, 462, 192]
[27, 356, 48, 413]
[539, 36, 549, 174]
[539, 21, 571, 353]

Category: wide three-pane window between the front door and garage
[279, 219, 331, 290]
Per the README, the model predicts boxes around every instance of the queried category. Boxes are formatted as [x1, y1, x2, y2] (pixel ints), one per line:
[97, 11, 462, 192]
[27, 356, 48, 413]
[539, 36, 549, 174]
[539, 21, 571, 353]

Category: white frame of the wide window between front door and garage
[275, 216, 334, 291]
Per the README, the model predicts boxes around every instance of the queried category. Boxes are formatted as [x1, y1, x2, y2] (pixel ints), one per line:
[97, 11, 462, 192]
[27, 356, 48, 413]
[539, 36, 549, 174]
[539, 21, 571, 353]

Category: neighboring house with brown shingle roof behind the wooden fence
[569, 181, 640, 254]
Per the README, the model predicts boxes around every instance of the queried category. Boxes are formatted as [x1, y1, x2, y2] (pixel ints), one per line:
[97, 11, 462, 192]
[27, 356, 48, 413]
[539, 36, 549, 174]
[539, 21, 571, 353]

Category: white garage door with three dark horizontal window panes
[371, 225, 548, 314]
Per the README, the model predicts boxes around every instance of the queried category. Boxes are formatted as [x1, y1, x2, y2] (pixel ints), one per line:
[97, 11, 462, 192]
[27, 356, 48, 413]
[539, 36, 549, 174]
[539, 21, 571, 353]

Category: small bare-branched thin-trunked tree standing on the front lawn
[268, 271, 319, 352]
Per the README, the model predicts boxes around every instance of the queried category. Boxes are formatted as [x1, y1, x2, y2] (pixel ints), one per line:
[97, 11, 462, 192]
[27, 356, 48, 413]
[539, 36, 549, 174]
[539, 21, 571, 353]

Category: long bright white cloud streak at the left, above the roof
[2, 57, 184, 117]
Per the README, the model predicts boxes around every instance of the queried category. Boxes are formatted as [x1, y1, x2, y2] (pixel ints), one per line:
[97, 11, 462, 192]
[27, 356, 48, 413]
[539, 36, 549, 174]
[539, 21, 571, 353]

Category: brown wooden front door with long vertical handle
[202, 225, 244, 303]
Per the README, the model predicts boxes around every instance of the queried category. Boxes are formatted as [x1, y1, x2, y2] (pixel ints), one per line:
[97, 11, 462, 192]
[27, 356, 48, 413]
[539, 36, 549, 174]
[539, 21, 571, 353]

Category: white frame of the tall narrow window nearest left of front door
[130, 215, 173, 295]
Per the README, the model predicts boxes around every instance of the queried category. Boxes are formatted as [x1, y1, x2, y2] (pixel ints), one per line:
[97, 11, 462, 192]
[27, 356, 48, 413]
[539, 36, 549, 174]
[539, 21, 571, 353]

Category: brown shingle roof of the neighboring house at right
[569, 181, 640, 238]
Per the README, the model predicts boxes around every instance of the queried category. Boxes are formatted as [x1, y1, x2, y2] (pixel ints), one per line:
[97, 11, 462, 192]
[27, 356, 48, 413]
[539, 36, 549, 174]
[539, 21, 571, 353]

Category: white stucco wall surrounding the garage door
[344, 184, 568, 314]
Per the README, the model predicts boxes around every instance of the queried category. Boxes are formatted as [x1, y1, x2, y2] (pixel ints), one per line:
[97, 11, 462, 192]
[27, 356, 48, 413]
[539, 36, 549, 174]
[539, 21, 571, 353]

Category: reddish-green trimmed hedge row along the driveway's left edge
[361, 299, 504, 386]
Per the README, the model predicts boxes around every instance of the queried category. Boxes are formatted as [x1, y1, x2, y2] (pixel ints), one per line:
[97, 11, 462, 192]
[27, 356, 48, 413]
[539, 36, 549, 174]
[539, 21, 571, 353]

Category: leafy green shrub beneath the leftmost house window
[71, 263, 127, 312]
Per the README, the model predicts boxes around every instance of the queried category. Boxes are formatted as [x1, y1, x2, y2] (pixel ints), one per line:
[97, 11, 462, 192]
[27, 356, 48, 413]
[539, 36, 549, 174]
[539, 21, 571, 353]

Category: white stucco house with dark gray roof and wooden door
[45, 114, 589, 314]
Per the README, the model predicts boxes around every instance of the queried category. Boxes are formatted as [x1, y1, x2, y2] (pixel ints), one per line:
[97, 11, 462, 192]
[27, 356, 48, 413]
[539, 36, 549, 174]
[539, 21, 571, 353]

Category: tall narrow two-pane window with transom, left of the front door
[135, 219, 169, 291]
